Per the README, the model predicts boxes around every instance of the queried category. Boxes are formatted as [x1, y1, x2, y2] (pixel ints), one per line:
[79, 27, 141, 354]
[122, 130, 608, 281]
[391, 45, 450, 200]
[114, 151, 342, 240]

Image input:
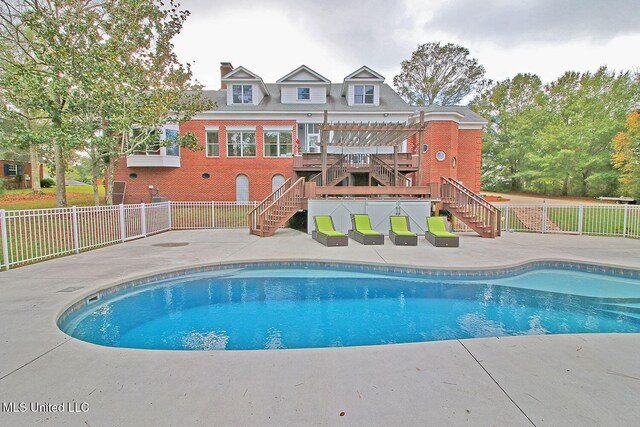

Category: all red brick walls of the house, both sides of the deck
[115, 120, 482, 203]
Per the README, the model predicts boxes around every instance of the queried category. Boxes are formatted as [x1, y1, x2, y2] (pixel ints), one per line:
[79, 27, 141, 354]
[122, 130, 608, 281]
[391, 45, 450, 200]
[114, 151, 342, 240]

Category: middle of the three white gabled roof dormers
[277, 65, 331, 104]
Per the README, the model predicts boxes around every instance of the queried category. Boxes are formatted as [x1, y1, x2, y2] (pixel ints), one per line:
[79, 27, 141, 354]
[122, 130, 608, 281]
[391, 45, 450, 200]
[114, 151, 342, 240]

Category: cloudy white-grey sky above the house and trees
[175, 0, 640, 89]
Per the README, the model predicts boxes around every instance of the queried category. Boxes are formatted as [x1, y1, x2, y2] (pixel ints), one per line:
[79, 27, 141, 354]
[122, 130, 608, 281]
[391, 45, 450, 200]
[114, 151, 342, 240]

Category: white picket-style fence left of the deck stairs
[0, 202, 257, 270]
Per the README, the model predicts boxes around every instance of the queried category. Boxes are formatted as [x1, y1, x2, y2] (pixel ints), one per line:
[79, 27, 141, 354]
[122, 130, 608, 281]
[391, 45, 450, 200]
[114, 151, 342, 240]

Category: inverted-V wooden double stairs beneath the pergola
[309, 154, 409, 187]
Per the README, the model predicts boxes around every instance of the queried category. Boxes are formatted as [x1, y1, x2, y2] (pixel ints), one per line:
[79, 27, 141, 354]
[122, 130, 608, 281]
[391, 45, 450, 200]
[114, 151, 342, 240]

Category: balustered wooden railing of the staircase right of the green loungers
[440, 177, 502, 237]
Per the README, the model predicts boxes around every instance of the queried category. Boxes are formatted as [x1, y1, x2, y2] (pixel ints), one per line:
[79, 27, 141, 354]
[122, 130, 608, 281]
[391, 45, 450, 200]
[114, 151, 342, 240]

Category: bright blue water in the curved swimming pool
[59, 266, 640, 350]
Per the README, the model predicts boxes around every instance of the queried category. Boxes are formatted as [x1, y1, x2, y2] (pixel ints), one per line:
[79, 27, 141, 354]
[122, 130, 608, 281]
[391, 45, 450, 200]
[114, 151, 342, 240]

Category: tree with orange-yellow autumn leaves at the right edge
[612, 111, 640, 198]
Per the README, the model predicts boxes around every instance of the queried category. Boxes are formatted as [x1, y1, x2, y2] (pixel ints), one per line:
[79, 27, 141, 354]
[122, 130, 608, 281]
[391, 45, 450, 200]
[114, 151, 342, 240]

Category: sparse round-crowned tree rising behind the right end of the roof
[393, 42, 485, 105]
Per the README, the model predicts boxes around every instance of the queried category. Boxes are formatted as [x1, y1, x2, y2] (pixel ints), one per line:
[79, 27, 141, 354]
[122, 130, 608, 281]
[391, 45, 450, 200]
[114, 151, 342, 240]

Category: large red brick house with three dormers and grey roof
[115, 62, 486, 203]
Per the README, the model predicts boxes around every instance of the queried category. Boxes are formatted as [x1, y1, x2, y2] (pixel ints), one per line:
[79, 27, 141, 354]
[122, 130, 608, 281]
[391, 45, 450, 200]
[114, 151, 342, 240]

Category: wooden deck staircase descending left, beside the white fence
[249, 178, 304, 237]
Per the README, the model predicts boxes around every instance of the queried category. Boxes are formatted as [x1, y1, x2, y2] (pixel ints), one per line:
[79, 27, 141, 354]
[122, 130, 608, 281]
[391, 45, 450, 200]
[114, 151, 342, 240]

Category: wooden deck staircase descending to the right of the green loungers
[440, 177, 501, 238]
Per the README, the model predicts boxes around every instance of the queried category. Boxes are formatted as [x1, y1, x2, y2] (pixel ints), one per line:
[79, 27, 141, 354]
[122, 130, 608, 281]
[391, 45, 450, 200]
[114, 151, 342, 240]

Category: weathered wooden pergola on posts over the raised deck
[320, 110, 427, 186]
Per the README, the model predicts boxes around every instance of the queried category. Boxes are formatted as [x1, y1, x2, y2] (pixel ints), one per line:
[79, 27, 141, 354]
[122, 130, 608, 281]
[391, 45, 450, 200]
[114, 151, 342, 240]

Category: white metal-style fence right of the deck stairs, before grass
[454, 204, 640, 238]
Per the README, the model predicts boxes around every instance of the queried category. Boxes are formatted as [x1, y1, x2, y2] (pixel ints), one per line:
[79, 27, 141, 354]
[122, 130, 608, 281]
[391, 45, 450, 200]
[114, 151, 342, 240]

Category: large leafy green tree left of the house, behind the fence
[0, 0, 211, 206]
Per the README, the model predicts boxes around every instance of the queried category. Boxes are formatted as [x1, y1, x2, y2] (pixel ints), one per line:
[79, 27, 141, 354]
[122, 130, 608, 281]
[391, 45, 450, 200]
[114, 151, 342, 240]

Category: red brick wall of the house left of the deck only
[115, 120, 296, 203]
